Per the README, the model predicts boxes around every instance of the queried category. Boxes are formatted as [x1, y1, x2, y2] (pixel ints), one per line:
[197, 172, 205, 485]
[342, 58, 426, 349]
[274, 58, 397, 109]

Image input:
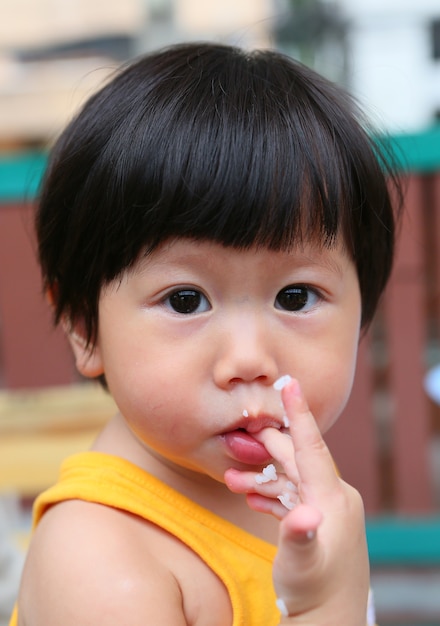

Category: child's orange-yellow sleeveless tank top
[9, 452, 280, 626]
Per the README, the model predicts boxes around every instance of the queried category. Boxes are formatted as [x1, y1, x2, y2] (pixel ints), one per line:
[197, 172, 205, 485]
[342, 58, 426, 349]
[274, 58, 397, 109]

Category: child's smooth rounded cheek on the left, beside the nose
[97, 316, 205, 439]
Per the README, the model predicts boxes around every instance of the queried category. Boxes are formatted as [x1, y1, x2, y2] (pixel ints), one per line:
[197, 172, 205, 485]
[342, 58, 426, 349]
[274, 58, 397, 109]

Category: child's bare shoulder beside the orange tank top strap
[19, 501, 187, 626]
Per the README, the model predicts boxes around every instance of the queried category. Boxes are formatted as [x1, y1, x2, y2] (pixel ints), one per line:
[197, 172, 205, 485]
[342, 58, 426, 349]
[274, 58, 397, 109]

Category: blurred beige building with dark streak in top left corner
[0, 0, 150, 148]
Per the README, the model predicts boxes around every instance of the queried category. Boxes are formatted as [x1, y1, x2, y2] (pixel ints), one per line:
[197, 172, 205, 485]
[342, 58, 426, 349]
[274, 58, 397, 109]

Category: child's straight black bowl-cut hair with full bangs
[36, 43, 402, 342]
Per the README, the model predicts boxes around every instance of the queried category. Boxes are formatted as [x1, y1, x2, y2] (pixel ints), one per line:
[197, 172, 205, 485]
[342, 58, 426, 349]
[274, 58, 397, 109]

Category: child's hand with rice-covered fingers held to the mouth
[225, 380, 369, 626]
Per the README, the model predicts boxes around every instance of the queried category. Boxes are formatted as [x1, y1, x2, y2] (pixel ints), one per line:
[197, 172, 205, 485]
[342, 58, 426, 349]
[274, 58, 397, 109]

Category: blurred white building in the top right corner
[339, 0, 440, 132]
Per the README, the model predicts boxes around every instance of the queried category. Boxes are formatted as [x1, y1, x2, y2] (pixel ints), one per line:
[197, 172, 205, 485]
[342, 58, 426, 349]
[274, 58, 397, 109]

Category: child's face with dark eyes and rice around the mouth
[71, 239, 361, 480]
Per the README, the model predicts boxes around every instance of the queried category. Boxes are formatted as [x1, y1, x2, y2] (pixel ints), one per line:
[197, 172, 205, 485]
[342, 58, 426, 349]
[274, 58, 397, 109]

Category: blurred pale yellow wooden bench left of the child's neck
[0, 383, 116, 500]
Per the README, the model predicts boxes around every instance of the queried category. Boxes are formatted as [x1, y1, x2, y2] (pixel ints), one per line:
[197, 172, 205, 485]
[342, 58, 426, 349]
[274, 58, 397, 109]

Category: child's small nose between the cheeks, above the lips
[214, 313, 279, 389]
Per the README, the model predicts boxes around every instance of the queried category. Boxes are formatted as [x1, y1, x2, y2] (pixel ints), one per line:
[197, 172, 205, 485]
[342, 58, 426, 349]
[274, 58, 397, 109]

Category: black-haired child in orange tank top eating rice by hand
[11, 44, 400, 626]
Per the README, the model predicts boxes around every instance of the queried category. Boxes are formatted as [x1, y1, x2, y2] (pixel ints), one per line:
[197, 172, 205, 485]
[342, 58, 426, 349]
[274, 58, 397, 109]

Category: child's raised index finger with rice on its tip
[282, 380, 340, 498]
